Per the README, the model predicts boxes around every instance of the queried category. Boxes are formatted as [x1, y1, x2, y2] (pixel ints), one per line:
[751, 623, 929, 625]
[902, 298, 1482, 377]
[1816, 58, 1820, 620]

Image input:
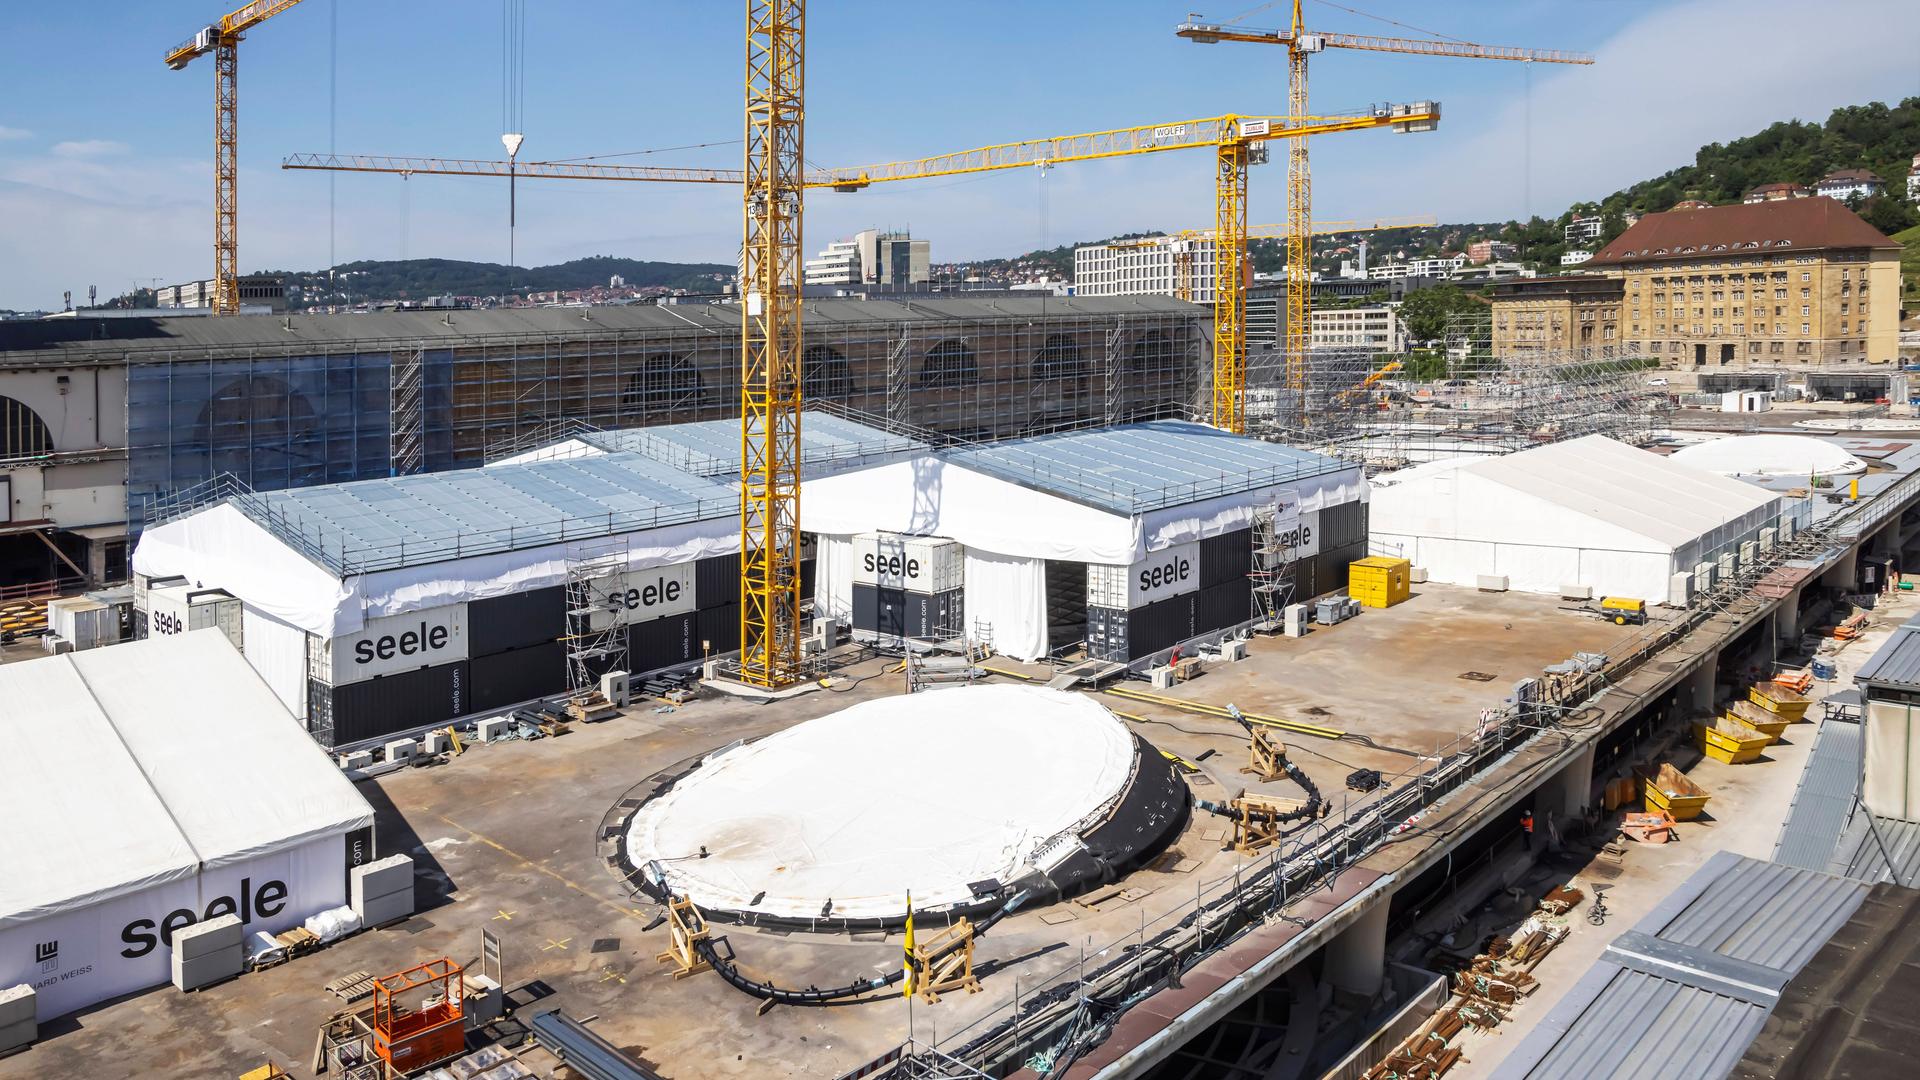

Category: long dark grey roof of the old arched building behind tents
[0, 296, 1210, 363]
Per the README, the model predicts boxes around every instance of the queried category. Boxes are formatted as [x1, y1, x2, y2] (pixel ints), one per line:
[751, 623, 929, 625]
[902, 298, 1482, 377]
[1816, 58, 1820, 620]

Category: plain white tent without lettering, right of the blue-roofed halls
[1369, 434, 1782, 600]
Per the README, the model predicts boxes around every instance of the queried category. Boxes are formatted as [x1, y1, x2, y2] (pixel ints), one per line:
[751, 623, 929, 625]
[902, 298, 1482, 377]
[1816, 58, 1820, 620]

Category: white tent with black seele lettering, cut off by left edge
[0, 630, 372, 1020]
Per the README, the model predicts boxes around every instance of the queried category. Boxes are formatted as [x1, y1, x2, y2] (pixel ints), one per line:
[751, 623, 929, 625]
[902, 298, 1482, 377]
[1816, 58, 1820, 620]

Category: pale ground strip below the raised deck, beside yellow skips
[1425, 592, 1920, 1080]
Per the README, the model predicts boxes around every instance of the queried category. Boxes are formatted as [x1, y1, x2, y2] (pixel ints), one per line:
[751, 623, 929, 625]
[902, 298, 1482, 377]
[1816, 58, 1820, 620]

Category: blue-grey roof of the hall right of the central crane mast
[941, 421, 1356, 515]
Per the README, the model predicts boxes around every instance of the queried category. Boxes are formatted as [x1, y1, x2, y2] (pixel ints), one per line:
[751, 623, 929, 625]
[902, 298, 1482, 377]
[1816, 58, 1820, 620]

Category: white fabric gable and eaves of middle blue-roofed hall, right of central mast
[801, 454, 1367, 567]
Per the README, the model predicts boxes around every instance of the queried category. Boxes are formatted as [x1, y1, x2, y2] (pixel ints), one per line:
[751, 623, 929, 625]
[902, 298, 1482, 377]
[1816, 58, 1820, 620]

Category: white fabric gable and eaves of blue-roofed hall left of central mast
[132, 503, 739, 640]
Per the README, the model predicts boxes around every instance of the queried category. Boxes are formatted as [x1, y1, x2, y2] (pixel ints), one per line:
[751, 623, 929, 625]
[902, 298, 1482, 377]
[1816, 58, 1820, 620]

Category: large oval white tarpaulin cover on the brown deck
[628, 686, 1135, 919]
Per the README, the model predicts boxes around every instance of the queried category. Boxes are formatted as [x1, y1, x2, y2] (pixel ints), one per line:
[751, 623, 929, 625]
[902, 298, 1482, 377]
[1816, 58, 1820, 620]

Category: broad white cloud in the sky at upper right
[1315, 0, 1920, 221]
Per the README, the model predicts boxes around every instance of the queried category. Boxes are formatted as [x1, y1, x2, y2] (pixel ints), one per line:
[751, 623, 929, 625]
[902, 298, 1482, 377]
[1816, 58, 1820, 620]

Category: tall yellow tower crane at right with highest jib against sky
[1175, 0, 1594, 427]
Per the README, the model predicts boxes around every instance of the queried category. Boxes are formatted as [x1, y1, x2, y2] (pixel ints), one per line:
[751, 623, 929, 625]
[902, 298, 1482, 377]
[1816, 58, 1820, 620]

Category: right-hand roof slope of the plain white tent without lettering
[1459, 434, 1780, 548]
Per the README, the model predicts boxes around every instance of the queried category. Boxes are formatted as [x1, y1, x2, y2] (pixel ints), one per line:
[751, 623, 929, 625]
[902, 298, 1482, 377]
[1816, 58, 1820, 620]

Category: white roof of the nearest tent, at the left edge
[0, 630, 372, 924]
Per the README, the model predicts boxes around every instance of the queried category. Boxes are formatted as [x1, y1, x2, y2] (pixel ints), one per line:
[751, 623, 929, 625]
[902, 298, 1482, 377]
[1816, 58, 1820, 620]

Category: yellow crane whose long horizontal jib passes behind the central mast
[282, 102, 1440, 434]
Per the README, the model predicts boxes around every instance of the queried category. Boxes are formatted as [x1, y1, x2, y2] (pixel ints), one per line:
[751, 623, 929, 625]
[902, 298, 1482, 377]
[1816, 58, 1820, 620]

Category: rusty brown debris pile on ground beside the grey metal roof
[1365, 899, 1586, 1080]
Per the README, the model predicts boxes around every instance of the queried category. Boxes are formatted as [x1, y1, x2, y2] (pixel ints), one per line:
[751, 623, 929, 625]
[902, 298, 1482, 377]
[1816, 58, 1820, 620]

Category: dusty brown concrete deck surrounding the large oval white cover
[0, 584, 1651, 1080]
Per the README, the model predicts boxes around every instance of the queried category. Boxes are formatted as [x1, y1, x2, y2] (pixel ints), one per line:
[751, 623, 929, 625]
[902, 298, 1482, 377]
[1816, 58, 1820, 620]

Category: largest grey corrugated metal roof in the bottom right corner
[1494, 851, 1866, 1080]
